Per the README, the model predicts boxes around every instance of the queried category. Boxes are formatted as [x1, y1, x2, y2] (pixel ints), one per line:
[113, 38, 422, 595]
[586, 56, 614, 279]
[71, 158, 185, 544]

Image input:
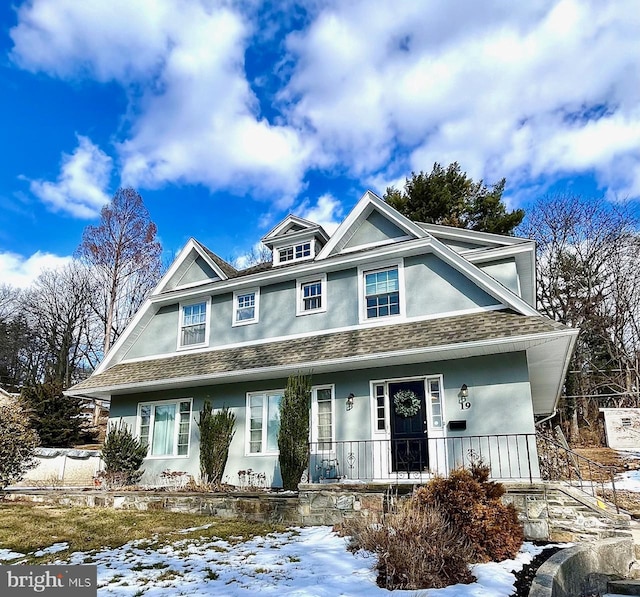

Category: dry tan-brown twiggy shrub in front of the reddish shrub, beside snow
[343, 500, 474, 590]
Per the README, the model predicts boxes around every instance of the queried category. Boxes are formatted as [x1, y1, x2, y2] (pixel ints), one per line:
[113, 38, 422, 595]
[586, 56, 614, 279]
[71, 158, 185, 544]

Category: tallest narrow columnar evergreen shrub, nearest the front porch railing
[278, 374, 311, 490]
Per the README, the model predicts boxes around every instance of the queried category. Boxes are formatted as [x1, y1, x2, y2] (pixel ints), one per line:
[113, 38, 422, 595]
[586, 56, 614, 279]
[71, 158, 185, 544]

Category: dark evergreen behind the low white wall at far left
[22, 382, 95, 448]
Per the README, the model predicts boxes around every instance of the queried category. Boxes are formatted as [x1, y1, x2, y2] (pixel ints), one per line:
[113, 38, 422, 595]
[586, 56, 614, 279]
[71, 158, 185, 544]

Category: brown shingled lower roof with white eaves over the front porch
[66, 311, 577, 414]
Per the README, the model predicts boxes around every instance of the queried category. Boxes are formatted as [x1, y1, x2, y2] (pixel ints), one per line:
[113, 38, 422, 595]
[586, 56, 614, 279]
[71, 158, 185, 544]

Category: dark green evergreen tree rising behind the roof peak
[384, 162, 524, 234]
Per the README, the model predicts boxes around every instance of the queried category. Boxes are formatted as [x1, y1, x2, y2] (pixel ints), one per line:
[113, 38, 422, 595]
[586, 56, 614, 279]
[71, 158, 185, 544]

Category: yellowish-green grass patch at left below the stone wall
[0, 503, 286, 563]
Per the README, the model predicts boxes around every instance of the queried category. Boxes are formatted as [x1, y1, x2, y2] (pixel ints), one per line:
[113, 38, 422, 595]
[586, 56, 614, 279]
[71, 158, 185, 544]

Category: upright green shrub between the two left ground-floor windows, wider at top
[198, 400, 236, 488]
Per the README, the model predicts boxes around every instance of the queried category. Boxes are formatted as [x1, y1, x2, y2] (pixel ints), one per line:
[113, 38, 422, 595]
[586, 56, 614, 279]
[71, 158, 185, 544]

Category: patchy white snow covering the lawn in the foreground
[0, 527, 556, 597]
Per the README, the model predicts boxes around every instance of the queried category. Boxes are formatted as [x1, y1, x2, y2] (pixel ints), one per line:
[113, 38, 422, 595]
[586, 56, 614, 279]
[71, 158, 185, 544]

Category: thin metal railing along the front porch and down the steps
[309, 433, 618, 509]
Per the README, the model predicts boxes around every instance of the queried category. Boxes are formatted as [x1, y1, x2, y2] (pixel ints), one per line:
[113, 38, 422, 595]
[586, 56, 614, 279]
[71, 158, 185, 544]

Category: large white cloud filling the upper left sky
[11, 0, 311, 207]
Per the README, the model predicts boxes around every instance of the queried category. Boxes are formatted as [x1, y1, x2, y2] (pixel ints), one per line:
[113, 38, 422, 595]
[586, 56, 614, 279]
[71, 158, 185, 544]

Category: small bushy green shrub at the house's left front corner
[102, 421, 149, 486]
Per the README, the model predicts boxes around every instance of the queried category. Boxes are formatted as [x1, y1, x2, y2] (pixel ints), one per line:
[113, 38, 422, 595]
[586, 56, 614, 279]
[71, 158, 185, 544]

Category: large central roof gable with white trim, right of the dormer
[318, 191, 429, 259]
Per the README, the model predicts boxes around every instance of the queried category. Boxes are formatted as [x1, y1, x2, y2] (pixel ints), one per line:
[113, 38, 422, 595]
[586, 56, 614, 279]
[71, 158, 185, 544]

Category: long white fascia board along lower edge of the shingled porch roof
[72, 330, 573, 396]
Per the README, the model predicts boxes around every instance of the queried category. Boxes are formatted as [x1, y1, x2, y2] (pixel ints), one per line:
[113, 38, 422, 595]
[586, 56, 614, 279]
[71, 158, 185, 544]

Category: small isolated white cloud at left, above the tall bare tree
[29, 136, 112, 218]
